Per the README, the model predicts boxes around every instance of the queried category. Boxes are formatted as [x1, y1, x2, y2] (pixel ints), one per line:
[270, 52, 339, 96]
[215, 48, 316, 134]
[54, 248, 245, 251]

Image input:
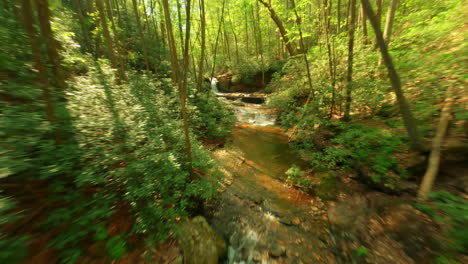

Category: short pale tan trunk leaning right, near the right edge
[418, 87, 454, 200]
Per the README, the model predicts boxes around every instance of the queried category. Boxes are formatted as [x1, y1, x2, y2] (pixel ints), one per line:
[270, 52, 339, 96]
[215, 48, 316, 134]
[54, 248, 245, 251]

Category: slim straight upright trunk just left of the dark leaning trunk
[344, 0, 356, 121]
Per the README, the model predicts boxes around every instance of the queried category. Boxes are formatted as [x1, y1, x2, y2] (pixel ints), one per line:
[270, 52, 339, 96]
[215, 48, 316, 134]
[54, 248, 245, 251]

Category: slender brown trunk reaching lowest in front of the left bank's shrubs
[162, 0, 194, 175]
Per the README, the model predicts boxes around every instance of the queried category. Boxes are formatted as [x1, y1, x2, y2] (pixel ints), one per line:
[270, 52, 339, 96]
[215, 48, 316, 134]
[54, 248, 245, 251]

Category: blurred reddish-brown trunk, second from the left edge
[36, 0, 66, 89]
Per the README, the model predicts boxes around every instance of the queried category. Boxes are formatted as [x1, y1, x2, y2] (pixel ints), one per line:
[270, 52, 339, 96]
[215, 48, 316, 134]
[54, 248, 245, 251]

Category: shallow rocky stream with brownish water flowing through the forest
[207, 95, 337, 264]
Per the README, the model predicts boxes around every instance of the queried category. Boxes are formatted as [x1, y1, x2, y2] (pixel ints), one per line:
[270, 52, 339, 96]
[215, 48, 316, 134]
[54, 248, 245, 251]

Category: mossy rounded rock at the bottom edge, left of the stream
[179, 216, 226, 264]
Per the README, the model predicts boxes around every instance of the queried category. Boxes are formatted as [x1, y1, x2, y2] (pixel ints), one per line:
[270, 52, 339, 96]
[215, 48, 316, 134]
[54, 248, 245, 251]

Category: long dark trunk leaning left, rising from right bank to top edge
[361, 0, 423, 151]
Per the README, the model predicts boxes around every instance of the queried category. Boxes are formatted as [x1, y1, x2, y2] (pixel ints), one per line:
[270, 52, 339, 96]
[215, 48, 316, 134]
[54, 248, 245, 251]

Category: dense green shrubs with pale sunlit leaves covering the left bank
[0, 1, 233, 264]
